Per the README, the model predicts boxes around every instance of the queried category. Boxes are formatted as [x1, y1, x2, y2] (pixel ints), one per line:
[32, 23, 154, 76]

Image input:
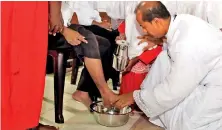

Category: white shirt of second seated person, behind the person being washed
[75, 1, 101, 26]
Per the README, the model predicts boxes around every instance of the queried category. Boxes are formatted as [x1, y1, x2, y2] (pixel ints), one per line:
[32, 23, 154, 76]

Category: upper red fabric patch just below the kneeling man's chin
[139, 46, 162, 65]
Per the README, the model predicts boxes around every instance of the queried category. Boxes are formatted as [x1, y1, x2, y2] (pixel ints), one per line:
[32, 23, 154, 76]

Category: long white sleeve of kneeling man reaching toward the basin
[134, 43, 212, 117]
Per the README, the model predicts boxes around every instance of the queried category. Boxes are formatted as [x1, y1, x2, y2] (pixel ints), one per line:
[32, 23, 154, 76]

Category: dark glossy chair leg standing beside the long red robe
[54, 53, 67, 123]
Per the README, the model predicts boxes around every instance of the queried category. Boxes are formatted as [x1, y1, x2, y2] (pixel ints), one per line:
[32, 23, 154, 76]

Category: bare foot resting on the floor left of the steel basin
[72, 90, 92, 108]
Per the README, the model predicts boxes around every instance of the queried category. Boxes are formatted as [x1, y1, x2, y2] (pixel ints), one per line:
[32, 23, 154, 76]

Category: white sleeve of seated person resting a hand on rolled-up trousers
[61, 1, 75, 27]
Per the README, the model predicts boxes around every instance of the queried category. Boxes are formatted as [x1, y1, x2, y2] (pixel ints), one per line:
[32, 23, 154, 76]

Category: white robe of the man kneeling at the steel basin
[134, 14, 222, 130]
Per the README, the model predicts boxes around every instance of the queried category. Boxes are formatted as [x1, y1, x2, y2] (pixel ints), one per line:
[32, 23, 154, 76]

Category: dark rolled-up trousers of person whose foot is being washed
[48, 24, 110, 61]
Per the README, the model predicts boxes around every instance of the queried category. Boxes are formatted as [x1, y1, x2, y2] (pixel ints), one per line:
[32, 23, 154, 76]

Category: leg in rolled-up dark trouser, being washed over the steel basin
[70, 25, 116, 105]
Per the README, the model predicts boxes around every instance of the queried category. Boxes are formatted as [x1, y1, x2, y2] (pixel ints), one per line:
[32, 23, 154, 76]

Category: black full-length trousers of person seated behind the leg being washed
[77, 25, 119, 98]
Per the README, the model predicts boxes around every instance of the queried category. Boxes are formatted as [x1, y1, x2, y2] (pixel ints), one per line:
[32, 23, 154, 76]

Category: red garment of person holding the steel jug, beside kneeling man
[120, 46, 162, 94]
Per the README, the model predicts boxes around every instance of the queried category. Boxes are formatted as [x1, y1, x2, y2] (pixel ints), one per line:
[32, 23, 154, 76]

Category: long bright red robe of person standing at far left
[1, 1, 48, 130]
